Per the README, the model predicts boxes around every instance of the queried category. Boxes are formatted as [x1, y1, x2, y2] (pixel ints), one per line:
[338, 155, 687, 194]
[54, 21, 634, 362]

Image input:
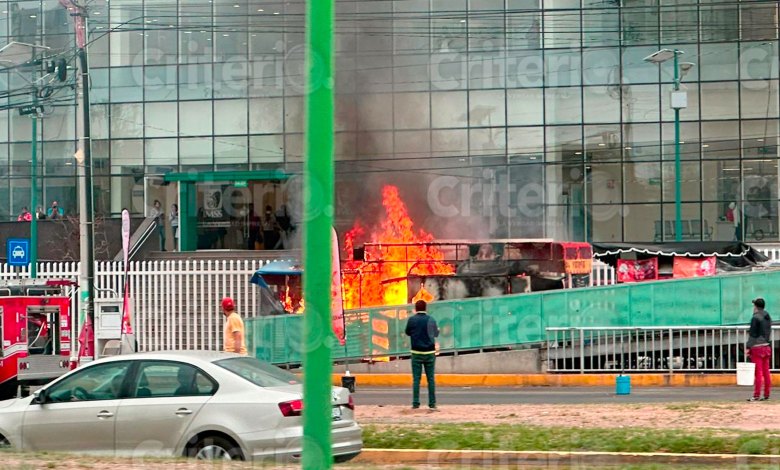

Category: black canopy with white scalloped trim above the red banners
[593, 242, 769, 271]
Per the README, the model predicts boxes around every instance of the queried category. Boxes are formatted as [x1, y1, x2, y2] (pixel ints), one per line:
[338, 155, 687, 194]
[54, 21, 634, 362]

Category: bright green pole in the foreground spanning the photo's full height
[302, 0, 335, 470]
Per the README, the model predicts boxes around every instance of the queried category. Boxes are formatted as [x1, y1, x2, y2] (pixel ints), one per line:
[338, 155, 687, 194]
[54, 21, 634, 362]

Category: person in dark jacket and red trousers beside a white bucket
[745, 298, 772, 401]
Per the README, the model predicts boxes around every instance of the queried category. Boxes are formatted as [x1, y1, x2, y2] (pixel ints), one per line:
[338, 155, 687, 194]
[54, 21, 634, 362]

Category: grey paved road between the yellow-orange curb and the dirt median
[355, 384, 752, 405]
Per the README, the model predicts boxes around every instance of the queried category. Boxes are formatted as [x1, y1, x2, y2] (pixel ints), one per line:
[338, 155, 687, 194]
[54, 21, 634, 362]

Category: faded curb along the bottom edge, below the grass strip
[352, 449, 780, 468]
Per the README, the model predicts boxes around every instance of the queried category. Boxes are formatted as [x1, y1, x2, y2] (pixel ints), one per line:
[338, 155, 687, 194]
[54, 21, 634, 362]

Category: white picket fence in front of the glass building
[0, 246, 780, 351]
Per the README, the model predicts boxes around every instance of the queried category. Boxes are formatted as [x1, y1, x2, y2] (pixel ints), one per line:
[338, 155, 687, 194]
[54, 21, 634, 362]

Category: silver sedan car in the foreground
[0, 351, 363, 461]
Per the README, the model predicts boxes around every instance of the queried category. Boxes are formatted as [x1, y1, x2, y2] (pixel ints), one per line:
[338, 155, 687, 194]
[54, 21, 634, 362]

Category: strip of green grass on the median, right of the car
[363, 423, 780, 455]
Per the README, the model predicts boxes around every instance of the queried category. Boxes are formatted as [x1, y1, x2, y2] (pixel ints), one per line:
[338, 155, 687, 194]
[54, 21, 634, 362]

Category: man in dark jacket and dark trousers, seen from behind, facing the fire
[406, 300, 439, 410]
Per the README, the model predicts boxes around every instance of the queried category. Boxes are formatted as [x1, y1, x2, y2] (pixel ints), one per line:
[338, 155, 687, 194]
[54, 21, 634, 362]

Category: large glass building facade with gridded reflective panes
[0, 0, 780, 248]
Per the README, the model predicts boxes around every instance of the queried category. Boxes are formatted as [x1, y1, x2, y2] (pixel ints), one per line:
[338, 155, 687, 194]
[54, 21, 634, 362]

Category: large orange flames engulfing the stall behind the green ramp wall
[342, 185, 455, 309]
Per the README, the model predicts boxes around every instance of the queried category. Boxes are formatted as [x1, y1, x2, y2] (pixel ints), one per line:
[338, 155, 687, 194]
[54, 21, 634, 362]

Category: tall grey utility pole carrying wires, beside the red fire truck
[59, 0, 97, 353]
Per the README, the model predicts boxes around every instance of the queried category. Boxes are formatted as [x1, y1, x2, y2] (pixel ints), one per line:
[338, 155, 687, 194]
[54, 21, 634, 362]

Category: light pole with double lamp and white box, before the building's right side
[644, 49, 696, 242]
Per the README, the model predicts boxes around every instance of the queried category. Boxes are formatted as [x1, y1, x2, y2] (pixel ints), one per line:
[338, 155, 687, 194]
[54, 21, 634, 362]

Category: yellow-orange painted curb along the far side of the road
[333, 372, 756, 387]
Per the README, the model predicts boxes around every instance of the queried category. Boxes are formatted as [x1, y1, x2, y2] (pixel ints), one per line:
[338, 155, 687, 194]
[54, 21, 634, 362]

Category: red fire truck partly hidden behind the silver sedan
[0, 279, 76, 399]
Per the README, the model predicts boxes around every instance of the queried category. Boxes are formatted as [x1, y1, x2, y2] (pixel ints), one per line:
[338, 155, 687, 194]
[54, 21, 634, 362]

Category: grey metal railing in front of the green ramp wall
[546, 325, 780, 373]
